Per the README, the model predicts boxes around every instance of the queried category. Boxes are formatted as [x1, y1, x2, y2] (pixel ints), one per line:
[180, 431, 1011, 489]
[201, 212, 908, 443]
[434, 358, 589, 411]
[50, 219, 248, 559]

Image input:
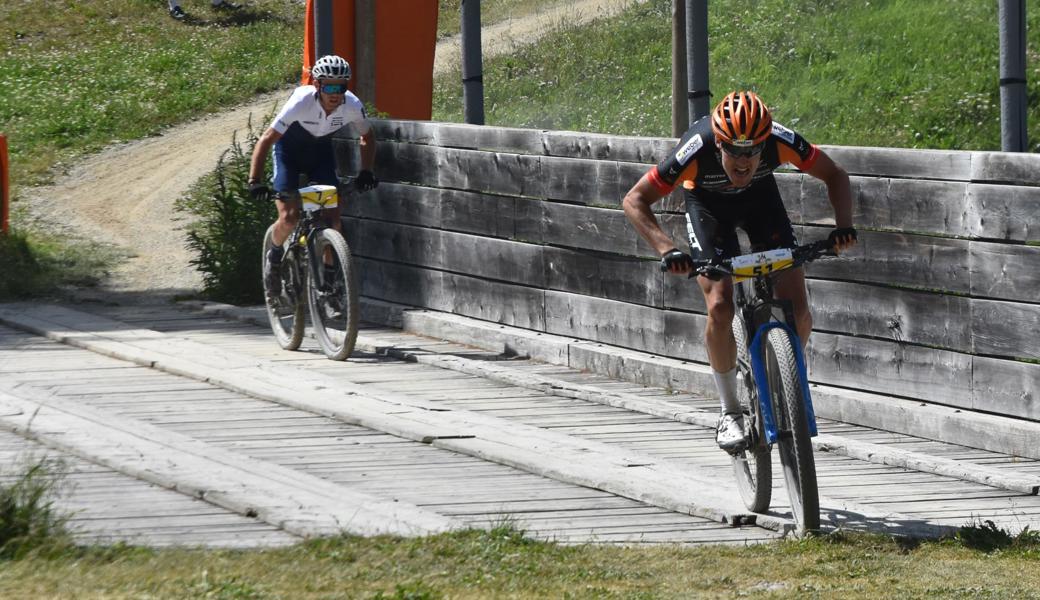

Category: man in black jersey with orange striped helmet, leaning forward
[622, 92, 856, 452]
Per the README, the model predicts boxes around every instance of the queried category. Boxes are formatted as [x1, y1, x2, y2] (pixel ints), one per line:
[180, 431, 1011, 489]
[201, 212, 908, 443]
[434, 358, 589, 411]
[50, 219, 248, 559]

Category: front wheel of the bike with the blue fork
[765, 329, 820, 532]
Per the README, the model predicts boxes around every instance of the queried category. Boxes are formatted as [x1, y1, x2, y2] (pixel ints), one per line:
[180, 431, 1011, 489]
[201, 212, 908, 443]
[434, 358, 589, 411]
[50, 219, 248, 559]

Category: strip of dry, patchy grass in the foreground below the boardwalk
[0, 526, 1040, 599]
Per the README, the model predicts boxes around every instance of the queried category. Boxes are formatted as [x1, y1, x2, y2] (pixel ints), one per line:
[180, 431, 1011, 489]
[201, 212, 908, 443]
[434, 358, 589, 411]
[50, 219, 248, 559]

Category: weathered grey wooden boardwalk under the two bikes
[0, 305, 1040, 546]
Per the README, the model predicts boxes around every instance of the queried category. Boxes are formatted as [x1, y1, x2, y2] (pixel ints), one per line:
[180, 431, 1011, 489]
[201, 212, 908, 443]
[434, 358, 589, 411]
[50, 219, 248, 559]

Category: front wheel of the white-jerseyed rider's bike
[307, 229, 361, 361]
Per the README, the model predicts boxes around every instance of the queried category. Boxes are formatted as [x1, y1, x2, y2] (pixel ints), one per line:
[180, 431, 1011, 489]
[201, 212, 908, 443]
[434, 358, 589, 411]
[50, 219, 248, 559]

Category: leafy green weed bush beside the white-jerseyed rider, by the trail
[176, 118, 278, 304]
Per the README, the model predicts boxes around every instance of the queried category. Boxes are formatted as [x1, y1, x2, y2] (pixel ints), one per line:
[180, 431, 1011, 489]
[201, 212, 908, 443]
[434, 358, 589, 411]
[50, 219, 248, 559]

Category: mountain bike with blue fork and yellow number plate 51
[673, 240, 836, 531]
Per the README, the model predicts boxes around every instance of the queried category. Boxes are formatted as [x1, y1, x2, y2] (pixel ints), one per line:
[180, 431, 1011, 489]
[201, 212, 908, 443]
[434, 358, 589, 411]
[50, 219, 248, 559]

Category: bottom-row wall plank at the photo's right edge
[971, 357, 1040, 421]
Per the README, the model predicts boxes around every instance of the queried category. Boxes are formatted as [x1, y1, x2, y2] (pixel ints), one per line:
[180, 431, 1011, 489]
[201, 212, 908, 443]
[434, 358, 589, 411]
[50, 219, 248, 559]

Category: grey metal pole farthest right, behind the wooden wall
[999, 0, 1028, 152]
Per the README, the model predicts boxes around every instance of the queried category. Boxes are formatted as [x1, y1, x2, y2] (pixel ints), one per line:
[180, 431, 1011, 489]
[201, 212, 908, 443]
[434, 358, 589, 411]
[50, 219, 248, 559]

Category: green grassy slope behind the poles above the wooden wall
[434, 0, 1040, 150]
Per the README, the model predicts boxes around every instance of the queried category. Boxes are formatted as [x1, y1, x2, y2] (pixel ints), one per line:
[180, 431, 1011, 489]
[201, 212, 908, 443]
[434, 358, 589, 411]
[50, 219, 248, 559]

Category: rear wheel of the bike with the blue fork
[730, 310, 773, 513]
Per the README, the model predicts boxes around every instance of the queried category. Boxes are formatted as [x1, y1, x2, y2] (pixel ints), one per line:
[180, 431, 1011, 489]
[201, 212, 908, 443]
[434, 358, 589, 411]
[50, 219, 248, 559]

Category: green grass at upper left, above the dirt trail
[0, 0, 303, 185]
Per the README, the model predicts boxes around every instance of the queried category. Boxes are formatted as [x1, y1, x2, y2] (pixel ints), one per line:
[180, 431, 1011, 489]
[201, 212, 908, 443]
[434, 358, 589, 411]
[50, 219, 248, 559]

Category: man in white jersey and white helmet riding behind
[249, 55, 379, 293]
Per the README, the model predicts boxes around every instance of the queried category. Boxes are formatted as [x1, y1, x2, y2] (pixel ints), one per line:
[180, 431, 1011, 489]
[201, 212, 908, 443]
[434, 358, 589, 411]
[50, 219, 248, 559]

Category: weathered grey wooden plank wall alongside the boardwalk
[336, 121, 1040, 420]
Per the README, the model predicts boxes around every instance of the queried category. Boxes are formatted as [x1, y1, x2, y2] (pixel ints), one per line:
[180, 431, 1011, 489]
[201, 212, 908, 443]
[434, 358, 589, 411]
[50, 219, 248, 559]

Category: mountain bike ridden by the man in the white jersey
[261, 180, 361, 361]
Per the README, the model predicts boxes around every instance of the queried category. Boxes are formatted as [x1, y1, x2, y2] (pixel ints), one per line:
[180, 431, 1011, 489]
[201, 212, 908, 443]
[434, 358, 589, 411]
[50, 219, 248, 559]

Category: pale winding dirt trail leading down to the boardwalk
[20, 0, 643, 302]
